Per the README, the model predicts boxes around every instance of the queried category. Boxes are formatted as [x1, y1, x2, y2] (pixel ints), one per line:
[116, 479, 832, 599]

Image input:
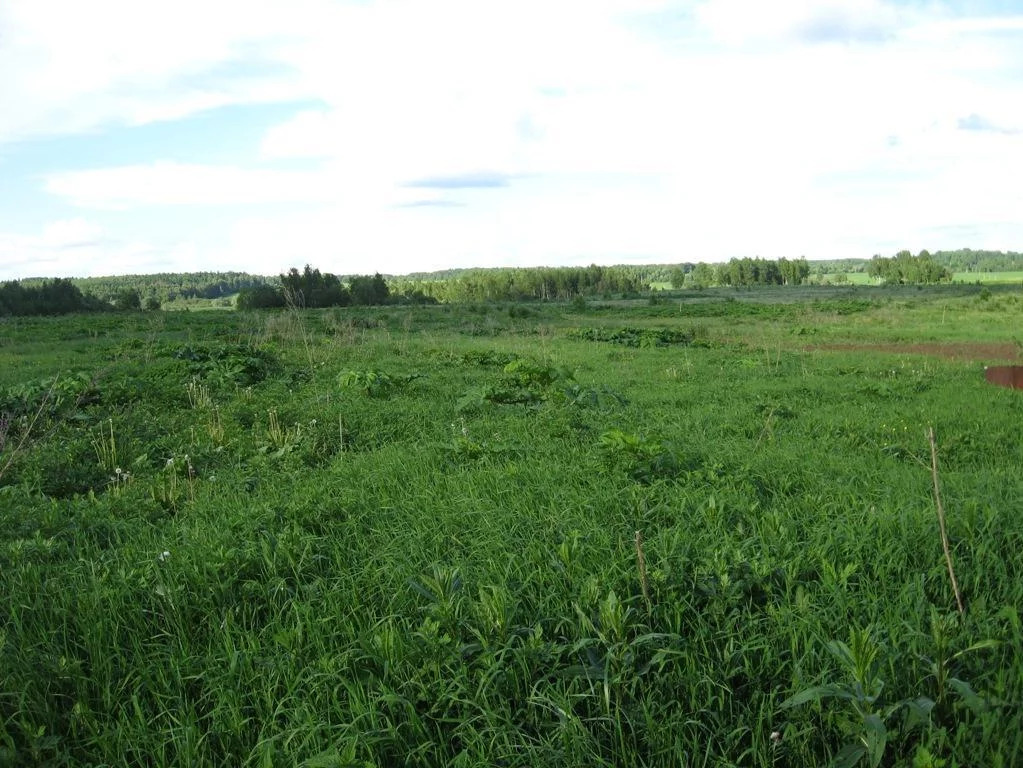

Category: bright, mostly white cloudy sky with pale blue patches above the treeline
[0, 0, 1023, 279]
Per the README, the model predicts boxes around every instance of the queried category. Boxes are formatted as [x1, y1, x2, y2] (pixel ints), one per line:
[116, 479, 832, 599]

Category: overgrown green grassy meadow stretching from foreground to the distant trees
[0, 286, 1023, 768]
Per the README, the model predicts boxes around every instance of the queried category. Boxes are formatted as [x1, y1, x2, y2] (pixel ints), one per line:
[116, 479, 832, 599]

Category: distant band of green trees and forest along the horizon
[0, 249, 1023, 317]
